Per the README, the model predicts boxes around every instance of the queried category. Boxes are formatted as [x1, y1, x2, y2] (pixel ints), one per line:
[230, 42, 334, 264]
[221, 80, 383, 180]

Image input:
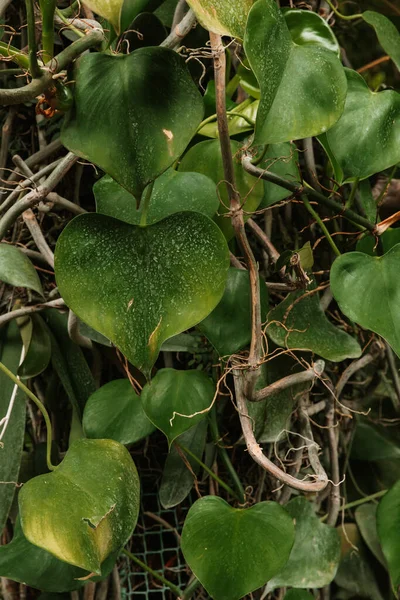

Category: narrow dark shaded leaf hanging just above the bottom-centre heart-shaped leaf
[159, 419, 208, 509]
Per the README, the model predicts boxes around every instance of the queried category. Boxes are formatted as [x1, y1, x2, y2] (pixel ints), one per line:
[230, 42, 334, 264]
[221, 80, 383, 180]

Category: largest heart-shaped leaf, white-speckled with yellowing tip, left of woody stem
[55, 212, 229, 377]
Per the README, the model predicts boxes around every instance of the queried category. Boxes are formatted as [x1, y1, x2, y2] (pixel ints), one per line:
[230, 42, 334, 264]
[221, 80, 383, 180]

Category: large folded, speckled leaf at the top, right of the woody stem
[244, 0, 347, 145]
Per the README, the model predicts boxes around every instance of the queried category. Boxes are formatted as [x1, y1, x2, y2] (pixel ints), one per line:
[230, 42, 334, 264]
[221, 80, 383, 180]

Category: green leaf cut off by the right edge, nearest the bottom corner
[377, 481, 400, 588]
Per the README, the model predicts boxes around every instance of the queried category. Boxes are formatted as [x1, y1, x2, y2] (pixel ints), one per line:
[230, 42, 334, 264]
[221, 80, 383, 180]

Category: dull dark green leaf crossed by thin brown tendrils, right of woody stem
[266, 280, 362, 362]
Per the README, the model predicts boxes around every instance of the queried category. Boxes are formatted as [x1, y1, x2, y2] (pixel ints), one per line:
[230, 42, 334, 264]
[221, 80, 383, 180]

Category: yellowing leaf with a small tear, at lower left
[18, 439, 140, 575]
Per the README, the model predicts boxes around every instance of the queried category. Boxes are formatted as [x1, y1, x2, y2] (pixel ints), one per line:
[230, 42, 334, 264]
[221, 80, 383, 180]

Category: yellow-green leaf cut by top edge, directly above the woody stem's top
[188, 0, 254, 39]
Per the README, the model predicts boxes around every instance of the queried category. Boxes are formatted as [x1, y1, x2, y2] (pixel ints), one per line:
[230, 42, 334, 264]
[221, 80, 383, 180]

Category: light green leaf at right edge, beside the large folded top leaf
[320, 69, 400, 183]
